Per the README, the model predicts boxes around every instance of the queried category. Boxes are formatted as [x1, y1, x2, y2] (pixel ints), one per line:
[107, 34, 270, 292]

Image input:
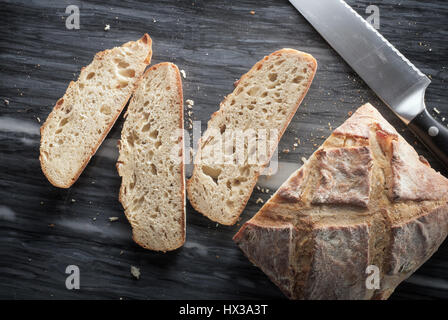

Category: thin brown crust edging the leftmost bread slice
[39, 33, 152, 189]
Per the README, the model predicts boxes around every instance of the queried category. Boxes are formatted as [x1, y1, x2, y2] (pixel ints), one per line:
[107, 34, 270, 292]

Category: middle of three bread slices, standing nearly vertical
[117, 62, 185, 251]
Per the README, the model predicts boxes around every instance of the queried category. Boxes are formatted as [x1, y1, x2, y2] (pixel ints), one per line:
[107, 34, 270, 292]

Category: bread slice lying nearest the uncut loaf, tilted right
[187, 49, 317, 225]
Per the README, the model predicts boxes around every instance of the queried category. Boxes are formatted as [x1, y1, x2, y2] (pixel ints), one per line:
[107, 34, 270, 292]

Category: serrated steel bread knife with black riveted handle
[289, 0, 448, 168]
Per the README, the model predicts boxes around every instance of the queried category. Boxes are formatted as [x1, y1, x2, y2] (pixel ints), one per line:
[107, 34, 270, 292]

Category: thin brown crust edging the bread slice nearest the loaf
[187, 48, 317, 226]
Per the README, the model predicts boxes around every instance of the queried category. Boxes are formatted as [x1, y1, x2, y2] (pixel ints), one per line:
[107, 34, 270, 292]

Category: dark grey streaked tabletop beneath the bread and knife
[0, 0, 448, 299]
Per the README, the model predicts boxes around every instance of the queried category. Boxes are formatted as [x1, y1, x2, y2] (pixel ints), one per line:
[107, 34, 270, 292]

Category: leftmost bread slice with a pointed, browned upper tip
[39, 34, 152, 188]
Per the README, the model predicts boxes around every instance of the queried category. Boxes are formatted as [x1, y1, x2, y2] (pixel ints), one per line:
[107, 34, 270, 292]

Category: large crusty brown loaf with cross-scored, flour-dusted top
[234, 104, 448, 299]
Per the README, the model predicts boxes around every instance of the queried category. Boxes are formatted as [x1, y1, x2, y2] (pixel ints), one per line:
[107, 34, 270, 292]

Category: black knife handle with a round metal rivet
[408, 108, 448, 168]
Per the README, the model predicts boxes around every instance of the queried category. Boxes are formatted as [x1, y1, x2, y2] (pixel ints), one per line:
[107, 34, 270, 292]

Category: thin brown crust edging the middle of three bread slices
[116, 62, 186, 253]
